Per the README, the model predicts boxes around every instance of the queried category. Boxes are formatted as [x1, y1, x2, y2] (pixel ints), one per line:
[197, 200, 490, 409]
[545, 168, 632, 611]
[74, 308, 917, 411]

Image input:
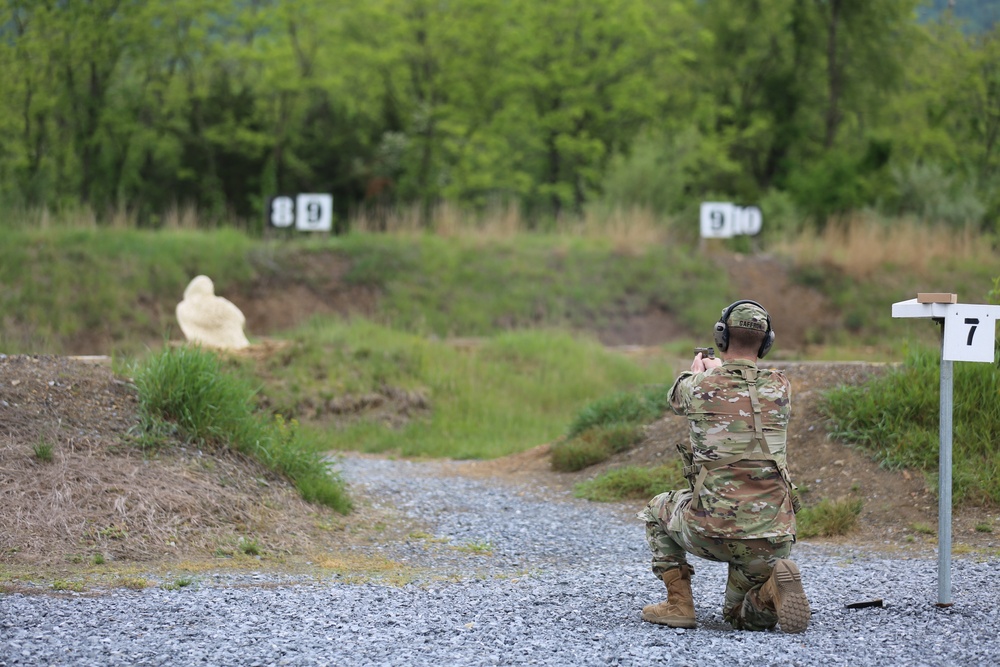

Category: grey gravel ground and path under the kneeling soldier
[0, 457, 1000, 667]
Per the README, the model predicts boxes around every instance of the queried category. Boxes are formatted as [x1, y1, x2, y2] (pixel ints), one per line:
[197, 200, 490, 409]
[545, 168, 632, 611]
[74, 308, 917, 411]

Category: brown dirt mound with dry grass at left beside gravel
[0, 355, 348, 565]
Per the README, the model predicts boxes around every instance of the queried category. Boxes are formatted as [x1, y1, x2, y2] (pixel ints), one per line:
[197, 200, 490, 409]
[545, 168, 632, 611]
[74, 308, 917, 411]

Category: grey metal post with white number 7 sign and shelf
[892, 293, 1000, 607]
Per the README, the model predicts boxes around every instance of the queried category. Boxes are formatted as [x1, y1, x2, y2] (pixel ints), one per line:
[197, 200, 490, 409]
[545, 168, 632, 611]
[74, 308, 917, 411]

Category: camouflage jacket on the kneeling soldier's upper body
[670, 359, 795, 539]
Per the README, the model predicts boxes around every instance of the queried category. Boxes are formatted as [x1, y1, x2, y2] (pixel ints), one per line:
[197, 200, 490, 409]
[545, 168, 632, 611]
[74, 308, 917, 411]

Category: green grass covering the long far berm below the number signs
[0, 225, 996, 358]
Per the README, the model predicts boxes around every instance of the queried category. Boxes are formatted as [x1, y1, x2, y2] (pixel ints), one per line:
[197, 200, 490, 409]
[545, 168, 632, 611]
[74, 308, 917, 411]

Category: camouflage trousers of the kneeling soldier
[638, 490, 792, 630]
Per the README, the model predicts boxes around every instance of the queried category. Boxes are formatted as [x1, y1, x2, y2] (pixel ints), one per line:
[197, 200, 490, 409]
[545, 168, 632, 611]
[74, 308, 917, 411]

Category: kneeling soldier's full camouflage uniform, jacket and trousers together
[638, 308, 795, 630]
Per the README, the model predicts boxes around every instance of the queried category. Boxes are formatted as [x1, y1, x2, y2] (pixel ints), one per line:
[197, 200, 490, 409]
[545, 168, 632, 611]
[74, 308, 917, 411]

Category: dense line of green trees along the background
[0, 0, 1000, 228]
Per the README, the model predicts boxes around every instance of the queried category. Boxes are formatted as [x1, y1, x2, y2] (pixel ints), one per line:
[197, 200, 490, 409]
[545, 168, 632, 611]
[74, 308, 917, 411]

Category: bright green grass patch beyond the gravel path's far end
[247, 319, 672, 459]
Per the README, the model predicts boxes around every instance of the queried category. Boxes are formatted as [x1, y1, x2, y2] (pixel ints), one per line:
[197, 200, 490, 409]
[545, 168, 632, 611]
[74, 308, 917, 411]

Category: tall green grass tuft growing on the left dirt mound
[135, 345, 351, 513]
